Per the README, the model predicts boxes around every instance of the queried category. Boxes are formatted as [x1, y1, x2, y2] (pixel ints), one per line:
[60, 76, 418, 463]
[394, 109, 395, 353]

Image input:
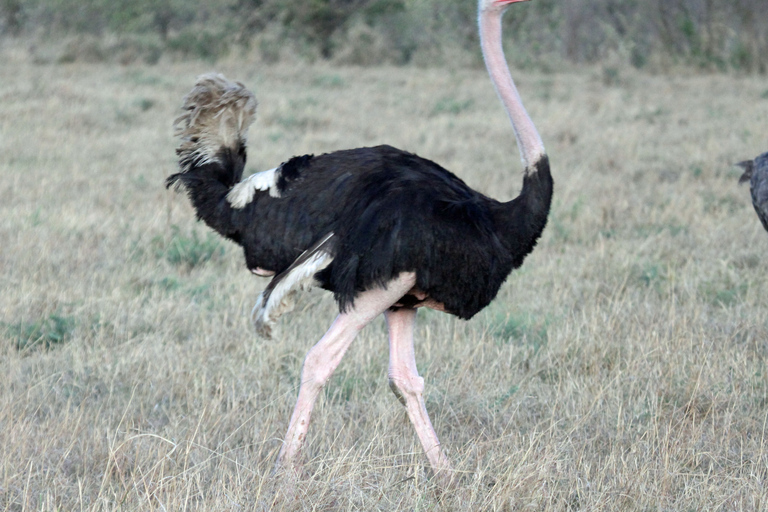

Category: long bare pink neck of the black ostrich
[480, 9, 545, 169]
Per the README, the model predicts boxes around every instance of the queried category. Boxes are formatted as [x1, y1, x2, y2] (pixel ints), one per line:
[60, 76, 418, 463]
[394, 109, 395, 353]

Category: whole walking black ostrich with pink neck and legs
[167, 0, 553, 479]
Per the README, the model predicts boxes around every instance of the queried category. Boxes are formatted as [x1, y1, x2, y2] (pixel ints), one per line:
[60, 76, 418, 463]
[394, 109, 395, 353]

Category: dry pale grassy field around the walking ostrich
[0, 45, 768, 511]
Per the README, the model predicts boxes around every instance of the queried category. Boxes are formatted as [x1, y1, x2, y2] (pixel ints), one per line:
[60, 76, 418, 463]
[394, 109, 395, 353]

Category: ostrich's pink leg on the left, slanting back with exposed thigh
[277, 272, 416, 467]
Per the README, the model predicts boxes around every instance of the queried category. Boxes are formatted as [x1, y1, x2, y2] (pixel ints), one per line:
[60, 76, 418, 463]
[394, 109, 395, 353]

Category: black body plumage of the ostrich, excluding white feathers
[169, 146, 552, 318]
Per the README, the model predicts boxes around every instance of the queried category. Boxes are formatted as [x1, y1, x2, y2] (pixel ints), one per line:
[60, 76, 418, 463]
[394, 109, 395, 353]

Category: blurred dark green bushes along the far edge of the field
[0, 0, 768, 73]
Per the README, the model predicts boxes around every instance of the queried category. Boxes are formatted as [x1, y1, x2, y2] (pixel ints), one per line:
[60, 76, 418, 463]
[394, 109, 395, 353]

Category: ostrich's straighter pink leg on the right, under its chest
[384, 308, 452, 483]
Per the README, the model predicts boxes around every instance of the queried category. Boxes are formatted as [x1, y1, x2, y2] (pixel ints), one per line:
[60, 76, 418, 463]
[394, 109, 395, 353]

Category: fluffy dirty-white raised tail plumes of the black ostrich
[167, 73, 256, 182]
